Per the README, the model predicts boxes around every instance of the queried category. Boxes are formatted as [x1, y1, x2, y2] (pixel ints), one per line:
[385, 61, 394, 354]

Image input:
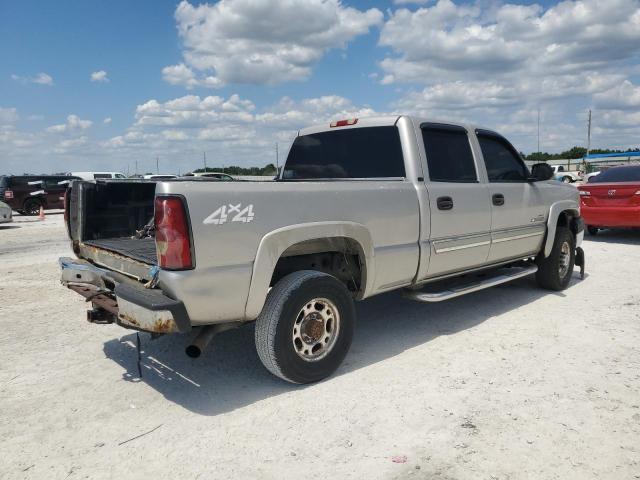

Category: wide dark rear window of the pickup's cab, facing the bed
[282, 126, 405, 180]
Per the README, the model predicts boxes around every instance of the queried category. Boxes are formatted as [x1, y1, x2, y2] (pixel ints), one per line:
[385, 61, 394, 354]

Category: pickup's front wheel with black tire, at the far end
[536, 226, 576, 291]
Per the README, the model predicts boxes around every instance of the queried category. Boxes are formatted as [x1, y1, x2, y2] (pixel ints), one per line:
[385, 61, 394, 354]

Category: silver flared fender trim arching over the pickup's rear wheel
[245, 222, 375, 320]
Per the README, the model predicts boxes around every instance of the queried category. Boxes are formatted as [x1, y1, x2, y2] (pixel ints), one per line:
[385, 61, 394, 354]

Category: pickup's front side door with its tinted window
[476, 130, 546, 262]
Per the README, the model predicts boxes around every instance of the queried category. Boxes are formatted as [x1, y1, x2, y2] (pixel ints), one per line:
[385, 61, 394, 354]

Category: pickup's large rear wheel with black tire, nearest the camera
[256, 270, 356, 383]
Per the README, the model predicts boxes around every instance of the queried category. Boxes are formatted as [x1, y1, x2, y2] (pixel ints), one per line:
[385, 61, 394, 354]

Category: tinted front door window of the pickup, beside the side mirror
[476, 130, 529, 183]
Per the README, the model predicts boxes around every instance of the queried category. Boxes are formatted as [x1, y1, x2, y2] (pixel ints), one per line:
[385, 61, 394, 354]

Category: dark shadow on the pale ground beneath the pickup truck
[104, 273, 580, 415]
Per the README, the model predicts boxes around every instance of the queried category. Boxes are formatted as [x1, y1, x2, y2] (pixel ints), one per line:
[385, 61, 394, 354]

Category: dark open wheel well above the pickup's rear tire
[270, 237, 366, 294]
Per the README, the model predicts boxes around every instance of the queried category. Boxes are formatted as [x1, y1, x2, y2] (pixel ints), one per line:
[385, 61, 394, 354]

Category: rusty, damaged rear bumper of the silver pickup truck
[59, 257, 191, 333]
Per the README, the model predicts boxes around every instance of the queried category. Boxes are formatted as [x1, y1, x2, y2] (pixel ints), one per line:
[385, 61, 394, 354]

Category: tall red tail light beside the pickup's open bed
[154, 195, 194, 270]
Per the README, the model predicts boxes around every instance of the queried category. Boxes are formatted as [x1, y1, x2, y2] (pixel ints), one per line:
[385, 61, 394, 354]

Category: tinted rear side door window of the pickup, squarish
[422, 124, 478, 183]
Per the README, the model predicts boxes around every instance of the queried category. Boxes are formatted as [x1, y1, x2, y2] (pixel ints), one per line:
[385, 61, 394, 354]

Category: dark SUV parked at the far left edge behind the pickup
[0, 175, 79, 215]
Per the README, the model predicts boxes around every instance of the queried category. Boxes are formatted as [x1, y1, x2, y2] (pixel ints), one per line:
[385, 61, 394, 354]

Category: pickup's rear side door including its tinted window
[420, 123, 491, 277]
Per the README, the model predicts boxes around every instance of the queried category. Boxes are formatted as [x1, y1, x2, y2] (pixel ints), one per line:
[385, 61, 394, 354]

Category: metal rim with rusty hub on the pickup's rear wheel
[291, 298, 340, 362]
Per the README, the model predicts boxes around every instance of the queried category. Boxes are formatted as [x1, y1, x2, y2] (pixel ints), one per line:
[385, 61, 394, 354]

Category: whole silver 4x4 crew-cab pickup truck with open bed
[60, 116, 584, 383]
